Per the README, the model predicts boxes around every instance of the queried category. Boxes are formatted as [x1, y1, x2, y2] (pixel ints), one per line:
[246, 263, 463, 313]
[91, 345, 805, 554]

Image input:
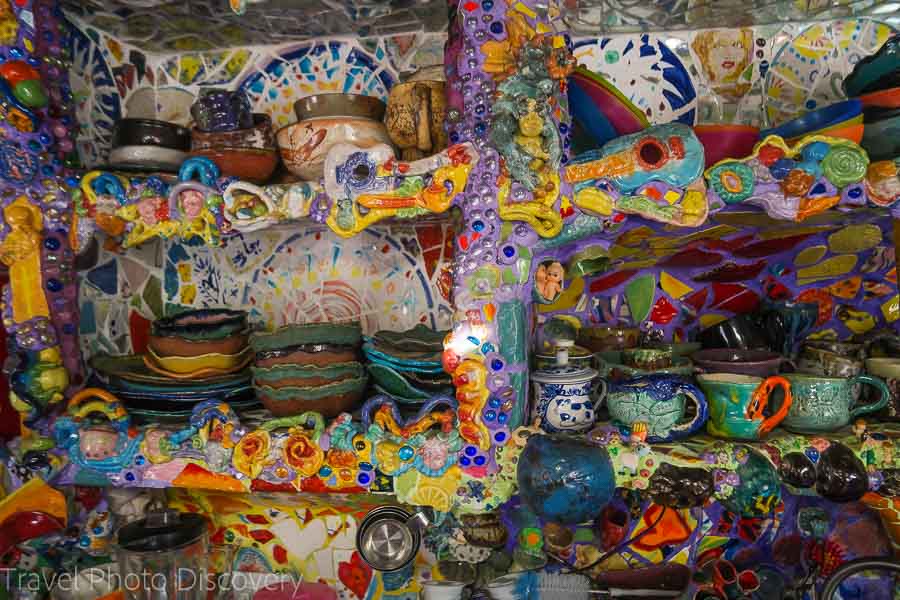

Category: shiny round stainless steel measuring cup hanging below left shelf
[356, 506, 427, 571]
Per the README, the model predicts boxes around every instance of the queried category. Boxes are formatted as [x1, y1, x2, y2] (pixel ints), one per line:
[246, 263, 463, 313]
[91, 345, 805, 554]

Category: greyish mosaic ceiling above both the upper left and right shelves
[63, 0, 900, 52]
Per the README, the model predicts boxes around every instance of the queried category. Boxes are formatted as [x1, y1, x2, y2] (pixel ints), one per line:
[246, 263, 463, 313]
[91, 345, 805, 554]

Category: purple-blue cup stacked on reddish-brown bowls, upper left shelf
[191, 90, 278, 183]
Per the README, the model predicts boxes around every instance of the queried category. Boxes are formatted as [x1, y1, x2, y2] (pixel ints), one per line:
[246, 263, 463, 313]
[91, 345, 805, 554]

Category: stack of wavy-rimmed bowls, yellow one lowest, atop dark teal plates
[144, 308, 252, 379]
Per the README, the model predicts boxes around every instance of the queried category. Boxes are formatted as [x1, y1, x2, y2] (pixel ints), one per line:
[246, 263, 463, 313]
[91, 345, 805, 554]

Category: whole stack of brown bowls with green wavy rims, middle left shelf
[250, 323, 366, 418]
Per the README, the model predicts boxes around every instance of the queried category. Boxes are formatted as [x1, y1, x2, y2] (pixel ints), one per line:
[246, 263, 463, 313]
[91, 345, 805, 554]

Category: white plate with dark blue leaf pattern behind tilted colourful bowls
[575, 33, 697, 125]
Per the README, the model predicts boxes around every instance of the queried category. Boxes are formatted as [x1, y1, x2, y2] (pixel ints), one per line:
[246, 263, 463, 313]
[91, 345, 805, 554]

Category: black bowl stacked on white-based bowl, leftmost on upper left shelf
[109, 119, 191, 173]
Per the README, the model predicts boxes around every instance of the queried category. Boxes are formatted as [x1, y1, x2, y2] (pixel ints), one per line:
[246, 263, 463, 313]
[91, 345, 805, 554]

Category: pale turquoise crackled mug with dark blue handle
[606, 375, 708, 442]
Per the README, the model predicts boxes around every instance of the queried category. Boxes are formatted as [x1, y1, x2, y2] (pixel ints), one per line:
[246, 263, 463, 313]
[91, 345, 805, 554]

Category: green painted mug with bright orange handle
[697, 373, 791, 440]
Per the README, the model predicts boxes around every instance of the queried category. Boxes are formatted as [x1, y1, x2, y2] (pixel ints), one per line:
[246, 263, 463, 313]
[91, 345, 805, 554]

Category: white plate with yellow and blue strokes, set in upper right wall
[763, 19, 895, 126]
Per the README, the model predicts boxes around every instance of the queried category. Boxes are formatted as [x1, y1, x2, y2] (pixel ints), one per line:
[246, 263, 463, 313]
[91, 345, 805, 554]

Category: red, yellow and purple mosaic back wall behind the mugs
[536, 210, 900, 341]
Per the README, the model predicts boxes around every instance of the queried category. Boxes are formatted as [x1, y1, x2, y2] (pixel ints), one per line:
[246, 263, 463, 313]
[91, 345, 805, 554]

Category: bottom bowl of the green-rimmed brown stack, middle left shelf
[256, 376, 367, 419]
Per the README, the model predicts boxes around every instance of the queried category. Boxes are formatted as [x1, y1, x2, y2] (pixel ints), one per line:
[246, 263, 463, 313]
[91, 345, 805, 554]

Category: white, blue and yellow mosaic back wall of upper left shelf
[64, 18, 446, 167]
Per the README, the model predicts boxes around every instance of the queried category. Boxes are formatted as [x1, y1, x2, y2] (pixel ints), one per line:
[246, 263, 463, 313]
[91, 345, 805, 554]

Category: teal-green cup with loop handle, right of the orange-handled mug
[784, 373, 891, 433]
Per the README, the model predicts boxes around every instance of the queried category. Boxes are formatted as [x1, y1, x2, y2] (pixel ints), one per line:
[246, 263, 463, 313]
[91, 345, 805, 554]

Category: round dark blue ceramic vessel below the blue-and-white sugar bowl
[516, 435, 616, 525]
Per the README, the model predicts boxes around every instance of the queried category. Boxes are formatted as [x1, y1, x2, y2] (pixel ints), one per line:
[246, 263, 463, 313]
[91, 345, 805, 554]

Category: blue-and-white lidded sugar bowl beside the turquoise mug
[531, 340, 606, 433]
